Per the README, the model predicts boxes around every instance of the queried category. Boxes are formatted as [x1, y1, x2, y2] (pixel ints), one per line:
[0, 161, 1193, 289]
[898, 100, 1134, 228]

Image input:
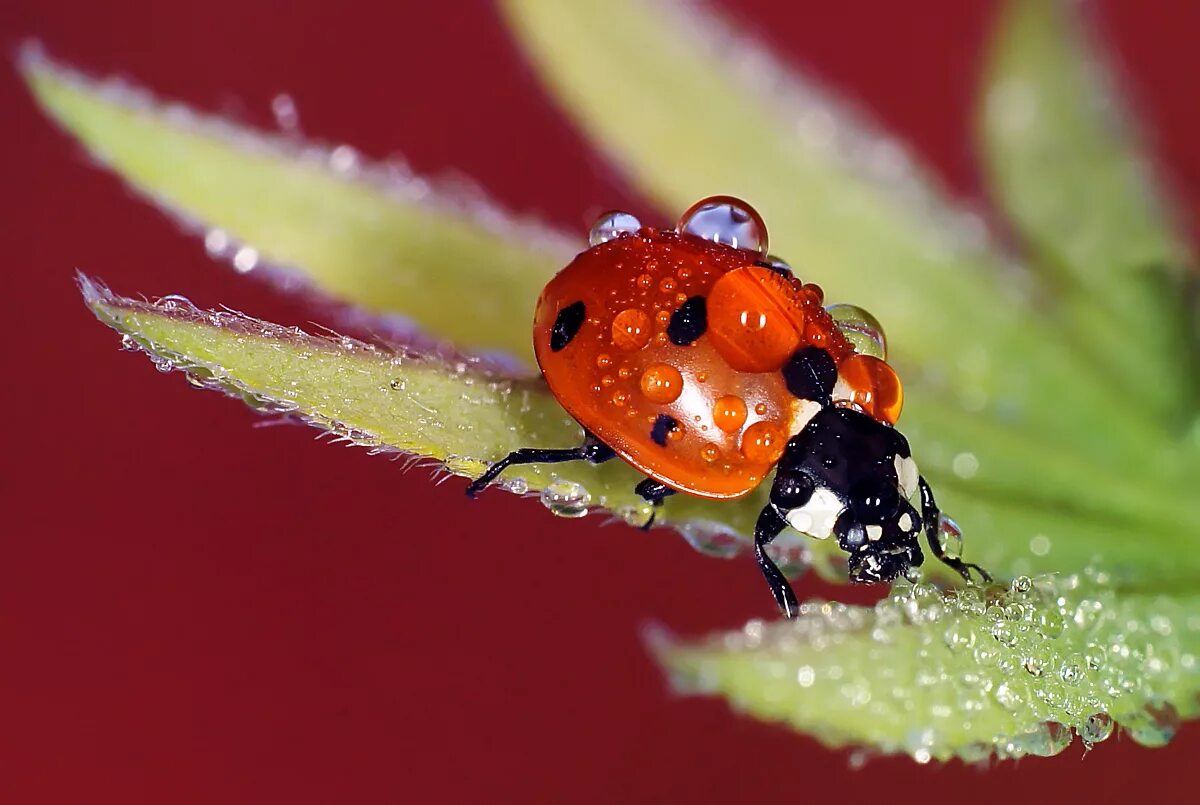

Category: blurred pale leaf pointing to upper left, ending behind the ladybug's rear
[22, 48, 578, 365]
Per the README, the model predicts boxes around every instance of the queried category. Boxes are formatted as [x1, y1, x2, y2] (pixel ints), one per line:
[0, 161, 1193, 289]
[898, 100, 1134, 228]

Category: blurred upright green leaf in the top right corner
[980, 0, 1196, 425]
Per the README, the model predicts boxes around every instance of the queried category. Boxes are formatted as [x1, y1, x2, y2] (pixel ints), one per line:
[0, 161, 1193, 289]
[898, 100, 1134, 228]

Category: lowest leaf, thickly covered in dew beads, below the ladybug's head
[652, 572, 1200, 762]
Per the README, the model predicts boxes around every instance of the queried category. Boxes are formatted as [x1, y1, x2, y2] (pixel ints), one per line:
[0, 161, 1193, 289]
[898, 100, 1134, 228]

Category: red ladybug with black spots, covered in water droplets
[467, 196, 990, 617]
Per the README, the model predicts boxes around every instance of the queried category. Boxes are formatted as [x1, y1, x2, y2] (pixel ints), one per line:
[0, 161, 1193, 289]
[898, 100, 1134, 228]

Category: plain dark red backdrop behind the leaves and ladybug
[0, 0, 1200, 803]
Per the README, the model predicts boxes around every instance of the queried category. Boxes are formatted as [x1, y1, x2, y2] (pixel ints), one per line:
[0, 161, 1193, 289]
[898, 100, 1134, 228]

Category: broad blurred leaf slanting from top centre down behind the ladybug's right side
[503, 0, 1200, 583]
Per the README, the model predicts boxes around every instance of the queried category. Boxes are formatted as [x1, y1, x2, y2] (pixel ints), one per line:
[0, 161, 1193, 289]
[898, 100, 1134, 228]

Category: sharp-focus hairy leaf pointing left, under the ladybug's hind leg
[79, 277, 845, 579]
